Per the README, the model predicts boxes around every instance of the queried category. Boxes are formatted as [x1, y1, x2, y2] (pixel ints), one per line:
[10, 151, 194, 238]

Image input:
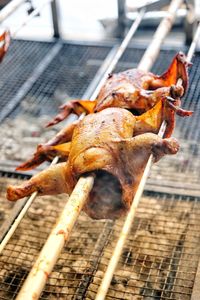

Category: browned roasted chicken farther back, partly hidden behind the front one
[47, 52, 189, 126]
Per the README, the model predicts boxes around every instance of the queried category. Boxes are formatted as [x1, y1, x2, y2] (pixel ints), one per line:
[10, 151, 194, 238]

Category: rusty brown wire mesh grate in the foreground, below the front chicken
[0, 179, 200, 300]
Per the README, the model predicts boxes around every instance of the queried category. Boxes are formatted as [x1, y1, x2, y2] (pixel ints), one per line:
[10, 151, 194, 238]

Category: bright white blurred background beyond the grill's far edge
[0, 0, 200, 44]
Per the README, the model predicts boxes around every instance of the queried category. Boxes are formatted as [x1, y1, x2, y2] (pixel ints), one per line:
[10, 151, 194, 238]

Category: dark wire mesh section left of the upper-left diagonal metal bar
[0, 40, 54, 113]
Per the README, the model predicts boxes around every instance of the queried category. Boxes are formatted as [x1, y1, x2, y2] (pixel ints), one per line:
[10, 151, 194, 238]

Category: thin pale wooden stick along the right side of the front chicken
[95, 11, 200, 300]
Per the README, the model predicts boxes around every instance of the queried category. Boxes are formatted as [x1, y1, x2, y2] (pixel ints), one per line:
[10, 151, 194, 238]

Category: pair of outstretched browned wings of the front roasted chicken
[16, 95, 192, 171]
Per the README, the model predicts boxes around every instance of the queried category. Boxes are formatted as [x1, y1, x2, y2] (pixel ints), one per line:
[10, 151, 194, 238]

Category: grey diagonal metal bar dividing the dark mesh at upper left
[0, 42, 62, 123]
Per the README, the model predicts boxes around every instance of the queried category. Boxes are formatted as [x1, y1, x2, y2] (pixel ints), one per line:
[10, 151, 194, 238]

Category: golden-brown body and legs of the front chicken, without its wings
[7, 108, 179, 219]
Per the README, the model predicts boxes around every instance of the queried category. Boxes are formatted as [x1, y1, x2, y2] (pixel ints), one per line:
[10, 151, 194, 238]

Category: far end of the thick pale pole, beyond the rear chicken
[138, 0, 183, 70]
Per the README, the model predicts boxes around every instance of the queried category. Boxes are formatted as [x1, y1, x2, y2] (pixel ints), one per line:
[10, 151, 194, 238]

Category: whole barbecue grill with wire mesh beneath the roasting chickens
[0, 1, 200, 300]
